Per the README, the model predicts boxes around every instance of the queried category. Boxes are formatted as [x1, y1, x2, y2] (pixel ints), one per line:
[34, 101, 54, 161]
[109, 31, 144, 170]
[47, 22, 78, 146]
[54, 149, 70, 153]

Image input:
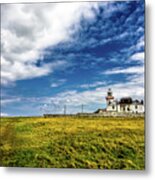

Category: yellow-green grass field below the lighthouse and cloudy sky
[0, 117, 145, 170]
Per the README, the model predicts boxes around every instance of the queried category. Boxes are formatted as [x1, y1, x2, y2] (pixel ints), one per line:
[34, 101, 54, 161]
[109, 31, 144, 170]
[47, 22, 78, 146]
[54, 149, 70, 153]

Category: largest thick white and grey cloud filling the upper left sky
[1, 2, 97, 84]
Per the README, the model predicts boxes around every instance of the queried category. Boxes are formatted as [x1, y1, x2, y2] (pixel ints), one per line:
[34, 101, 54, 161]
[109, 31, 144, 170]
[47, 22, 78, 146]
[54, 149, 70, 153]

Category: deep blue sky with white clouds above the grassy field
[1, 0, 145, 116]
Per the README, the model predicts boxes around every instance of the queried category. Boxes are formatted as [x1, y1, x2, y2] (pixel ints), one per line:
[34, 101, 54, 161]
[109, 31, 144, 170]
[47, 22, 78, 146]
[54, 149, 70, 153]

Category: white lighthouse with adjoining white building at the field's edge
[106, 89, 144, 113]
